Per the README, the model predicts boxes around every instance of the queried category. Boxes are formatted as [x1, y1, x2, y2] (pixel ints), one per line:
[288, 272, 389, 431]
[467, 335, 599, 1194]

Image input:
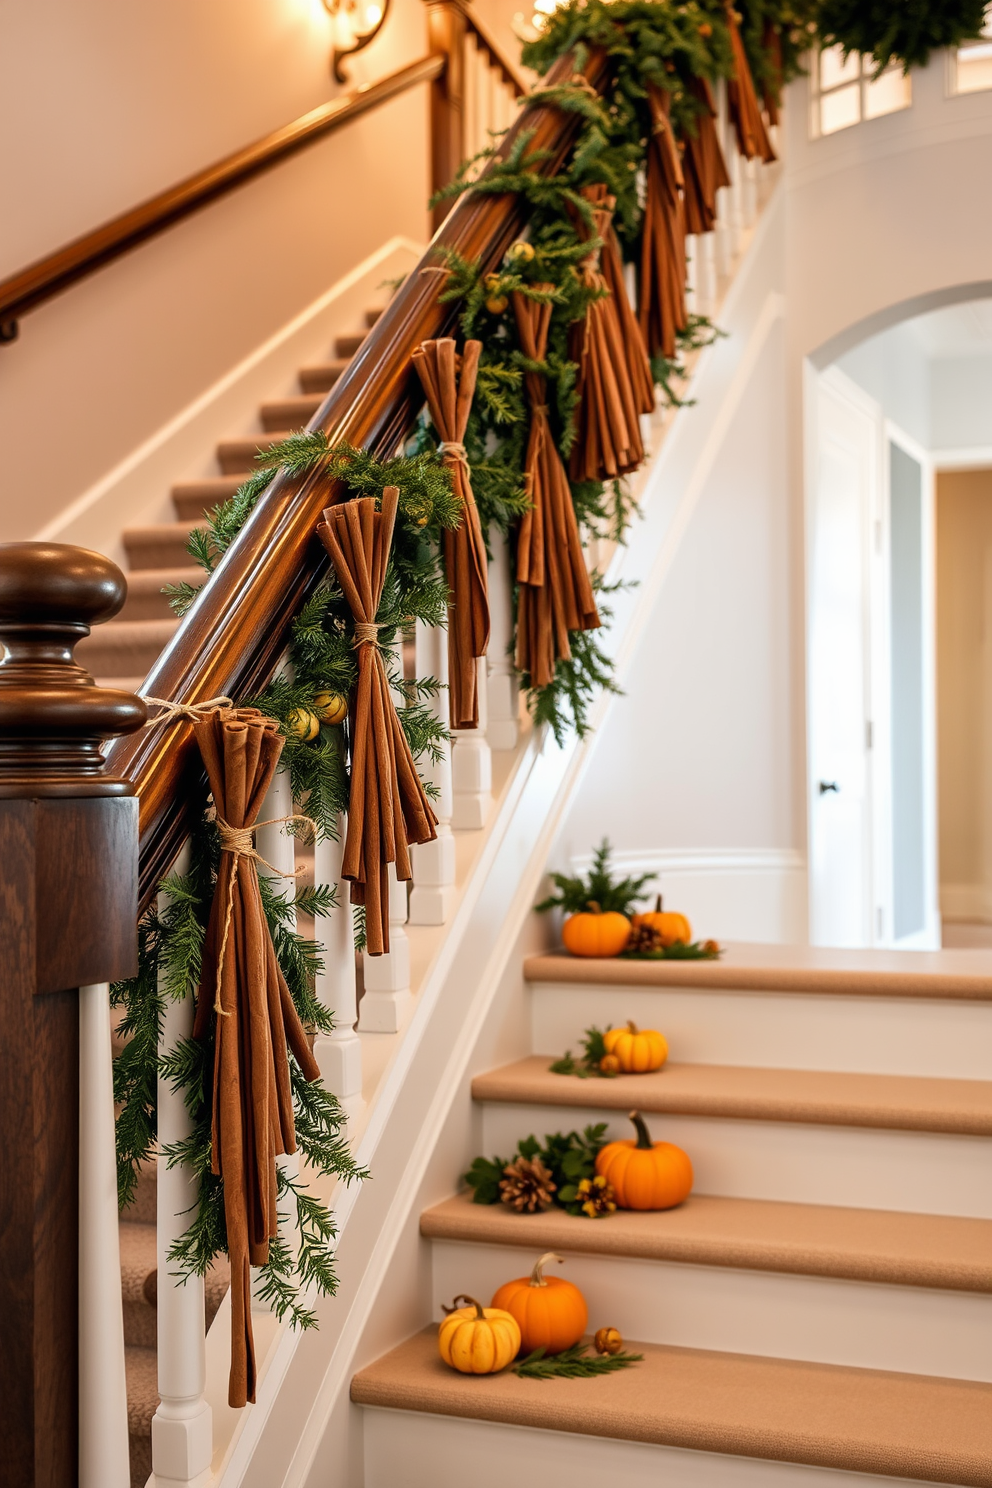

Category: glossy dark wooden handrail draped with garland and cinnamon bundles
[107, 52, 607, 906]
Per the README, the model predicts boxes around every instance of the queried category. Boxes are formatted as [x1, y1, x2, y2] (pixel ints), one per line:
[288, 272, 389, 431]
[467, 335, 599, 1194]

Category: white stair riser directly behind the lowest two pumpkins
[431, 1216, 992, 1381]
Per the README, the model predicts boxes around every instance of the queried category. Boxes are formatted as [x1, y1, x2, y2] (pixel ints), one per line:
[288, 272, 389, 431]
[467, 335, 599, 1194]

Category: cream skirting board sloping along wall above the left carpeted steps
[36, 237, 422, 562]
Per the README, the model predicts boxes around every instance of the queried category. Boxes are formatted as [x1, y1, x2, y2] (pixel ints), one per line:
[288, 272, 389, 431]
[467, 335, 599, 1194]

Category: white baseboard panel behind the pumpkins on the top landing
[571, 848, 806, 943]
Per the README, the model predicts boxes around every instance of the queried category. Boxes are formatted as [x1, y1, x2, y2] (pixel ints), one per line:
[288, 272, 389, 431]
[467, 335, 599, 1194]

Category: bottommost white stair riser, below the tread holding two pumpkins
[355, 1404, 951, 1488]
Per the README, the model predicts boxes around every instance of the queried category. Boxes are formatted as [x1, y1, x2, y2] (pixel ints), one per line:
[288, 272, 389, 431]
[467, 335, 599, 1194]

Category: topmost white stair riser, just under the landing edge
[531, 982, 992, 1080]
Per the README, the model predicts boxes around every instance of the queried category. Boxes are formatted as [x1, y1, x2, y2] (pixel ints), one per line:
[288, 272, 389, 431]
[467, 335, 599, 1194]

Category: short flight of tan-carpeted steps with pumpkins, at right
[351, 946, 992, 1488]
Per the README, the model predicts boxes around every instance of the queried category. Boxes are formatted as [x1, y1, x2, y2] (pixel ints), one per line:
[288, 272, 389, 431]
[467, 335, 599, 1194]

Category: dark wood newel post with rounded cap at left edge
[0, 543, 146, 1488]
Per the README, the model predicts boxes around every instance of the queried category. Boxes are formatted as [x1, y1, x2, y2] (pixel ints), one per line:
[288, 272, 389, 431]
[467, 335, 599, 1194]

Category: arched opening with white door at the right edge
[806, 283, 992, 949]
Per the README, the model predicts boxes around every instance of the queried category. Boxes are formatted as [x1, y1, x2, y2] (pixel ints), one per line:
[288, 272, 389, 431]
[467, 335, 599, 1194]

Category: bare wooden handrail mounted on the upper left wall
[0, 52, 446, 342]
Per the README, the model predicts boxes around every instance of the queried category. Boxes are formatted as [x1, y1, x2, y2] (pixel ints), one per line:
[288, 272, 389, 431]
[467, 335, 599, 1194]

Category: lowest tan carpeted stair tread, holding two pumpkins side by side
[351, 1327, 992, 1488]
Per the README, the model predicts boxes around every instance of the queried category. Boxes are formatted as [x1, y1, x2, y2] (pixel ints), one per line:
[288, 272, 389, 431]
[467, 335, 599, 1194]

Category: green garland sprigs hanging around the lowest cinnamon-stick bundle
[112, 821, 367, 1327]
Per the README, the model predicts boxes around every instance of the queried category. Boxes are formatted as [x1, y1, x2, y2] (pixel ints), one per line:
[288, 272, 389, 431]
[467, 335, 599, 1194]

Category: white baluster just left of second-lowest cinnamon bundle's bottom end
[314, 820, 364, 1122]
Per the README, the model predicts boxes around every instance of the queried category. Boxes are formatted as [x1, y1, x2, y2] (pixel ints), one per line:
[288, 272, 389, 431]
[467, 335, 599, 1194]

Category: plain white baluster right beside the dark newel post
[79, 982, 131, 1488]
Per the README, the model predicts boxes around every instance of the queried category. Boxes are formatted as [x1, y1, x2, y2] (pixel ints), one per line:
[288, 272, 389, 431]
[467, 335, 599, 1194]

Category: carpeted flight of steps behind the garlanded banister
[101, 310, 381, 1488]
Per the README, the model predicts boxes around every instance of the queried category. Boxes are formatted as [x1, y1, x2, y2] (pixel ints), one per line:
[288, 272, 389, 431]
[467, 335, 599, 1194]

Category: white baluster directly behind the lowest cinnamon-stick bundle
[152, 848, 213, 1488]
